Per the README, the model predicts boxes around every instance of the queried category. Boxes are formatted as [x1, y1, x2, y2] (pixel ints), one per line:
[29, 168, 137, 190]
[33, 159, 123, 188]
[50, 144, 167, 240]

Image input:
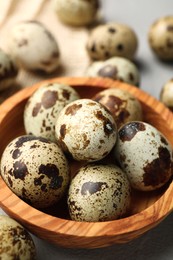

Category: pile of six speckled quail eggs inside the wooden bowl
[1, 83, 172, 222]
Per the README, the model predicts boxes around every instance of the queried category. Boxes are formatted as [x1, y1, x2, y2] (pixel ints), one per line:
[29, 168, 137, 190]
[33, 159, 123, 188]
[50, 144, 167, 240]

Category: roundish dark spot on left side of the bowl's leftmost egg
[12, 161, 28, 181]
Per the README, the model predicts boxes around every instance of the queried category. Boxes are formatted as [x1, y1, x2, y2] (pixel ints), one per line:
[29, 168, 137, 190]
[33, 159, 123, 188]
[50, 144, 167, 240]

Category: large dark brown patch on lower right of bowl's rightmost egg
[143, 147, 172, 187]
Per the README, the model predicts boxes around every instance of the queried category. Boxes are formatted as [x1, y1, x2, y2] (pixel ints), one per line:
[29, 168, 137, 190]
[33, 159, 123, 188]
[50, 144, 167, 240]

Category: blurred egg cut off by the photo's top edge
[54, 0, 99, 26]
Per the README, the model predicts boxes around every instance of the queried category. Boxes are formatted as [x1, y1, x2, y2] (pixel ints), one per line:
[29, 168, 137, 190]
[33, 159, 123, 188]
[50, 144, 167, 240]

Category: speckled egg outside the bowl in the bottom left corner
[0, 215, 36, 260]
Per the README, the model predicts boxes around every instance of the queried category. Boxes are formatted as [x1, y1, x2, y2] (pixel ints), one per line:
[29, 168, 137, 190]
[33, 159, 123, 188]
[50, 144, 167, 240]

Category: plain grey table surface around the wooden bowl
[0, 0, 173, 260]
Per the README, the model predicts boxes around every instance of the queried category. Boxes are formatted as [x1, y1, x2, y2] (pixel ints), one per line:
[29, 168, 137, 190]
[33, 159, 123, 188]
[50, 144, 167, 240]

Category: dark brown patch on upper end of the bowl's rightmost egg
[119, 122, 146, 142]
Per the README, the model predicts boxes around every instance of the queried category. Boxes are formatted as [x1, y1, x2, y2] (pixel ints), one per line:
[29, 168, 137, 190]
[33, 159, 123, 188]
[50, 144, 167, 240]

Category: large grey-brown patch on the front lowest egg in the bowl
[81, 181, 108, 195]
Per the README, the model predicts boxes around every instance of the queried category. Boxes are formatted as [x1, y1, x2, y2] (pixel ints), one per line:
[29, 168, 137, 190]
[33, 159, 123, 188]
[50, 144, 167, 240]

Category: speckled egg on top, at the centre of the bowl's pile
[55, 99, 117, 161]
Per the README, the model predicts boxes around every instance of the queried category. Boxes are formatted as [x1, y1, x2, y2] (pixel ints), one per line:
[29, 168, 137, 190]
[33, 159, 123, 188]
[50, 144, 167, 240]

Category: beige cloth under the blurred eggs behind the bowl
[0, 0, 92, 102]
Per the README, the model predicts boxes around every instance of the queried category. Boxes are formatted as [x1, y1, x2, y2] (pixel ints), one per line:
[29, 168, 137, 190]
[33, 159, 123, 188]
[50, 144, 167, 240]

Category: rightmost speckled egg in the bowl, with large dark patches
[114, 121, 172, 191]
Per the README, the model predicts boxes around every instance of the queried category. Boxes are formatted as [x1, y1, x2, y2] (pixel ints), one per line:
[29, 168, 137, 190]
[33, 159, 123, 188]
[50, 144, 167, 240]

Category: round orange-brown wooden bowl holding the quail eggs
[0, 78, 173, 248]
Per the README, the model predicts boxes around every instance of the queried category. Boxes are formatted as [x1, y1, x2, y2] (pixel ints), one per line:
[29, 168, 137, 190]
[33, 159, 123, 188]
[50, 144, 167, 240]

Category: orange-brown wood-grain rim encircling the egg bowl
[0, 77, 173, 247]
